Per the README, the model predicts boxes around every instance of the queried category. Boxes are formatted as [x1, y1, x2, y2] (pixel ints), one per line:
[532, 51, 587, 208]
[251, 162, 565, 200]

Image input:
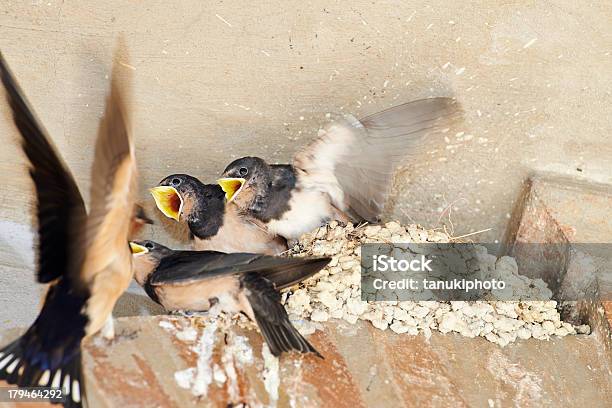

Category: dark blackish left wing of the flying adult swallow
[0, 55, 86, 283]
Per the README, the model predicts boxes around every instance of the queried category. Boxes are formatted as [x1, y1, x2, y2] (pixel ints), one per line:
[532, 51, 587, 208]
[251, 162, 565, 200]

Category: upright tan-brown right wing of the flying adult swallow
[82, 53, 137, 275]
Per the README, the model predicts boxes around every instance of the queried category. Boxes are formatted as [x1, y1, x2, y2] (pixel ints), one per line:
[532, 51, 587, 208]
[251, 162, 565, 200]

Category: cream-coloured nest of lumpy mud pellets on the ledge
[283, 222, 590, 346]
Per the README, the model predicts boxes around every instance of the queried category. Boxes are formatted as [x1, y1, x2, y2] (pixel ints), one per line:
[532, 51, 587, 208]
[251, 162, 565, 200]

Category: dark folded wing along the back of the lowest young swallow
[150, 251, 330, 289]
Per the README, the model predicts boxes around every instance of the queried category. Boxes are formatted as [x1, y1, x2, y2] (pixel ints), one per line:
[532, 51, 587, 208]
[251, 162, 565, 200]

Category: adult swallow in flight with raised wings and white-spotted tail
[0, 46, 142, 407]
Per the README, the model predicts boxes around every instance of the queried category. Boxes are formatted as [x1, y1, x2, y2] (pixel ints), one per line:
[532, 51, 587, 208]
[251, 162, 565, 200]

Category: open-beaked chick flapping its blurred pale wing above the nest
[218, 98, 460, 239]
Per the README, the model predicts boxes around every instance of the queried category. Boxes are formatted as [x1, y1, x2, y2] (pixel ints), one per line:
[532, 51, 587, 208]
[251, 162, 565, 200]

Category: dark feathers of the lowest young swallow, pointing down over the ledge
[240, 273, 323, 358]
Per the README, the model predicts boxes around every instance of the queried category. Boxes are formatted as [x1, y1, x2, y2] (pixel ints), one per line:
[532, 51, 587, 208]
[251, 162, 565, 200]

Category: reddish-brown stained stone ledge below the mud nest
[2, 316, 612, 407]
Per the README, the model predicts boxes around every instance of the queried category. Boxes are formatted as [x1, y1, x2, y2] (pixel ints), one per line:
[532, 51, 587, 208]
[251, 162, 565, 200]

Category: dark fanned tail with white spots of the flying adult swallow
[0, 333, 85, 407]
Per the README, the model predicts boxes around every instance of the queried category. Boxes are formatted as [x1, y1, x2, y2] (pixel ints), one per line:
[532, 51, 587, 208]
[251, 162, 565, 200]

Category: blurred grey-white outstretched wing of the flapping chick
[294, 98, 460, 222]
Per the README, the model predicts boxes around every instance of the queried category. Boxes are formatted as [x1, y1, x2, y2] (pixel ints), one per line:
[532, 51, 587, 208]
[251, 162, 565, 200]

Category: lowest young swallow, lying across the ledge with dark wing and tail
[130, 241, 330, 357]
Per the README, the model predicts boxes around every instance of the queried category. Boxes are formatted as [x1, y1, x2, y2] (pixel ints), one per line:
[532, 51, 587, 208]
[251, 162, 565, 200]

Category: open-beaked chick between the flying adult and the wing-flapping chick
[150, 174, 287, 255]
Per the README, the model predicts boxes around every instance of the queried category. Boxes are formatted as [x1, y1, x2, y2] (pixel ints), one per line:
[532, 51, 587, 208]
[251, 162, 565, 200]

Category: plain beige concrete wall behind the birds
[0, 0, 612, 325]
